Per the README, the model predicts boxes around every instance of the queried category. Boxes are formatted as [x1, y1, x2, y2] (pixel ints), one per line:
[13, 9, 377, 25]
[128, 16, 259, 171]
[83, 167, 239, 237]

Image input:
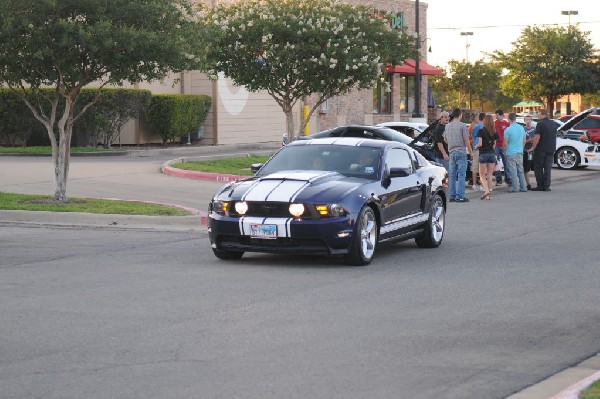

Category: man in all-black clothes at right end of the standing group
[529, 109, 558, 191]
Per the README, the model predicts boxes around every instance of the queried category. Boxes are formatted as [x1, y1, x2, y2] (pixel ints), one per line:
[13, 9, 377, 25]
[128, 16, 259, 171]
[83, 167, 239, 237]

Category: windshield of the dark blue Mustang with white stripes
[256, 144, 381, 180]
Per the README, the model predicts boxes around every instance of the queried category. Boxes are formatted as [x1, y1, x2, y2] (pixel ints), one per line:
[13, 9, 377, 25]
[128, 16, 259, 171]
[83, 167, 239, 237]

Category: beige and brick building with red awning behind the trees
[121, 0, 442, 145]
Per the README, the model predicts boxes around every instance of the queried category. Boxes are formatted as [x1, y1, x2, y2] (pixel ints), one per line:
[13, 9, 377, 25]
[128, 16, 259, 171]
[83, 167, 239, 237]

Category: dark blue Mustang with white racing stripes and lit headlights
[209, 138, 448, 265]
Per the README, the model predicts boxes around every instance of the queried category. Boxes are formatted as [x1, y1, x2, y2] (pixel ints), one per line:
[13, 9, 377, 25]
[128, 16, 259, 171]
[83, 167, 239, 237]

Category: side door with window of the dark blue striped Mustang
[381, 147, 426, 236]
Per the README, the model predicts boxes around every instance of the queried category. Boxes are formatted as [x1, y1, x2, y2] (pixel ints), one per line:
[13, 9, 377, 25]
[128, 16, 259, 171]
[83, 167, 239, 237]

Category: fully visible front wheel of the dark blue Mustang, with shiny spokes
[346, 206, 379, 266]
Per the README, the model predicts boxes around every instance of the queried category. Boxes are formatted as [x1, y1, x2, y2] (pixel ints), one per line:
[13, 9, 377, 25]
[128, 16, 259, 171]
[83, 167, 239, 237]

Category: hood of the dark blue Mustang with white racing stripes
[217, 171, 368, 202]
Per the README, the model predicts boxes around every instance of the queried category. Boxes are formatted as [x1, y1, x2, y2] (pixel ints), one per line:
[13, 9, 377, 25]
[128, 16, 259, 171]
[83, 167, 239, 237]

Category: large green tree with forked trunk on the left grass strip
[0, 0, 202, 201]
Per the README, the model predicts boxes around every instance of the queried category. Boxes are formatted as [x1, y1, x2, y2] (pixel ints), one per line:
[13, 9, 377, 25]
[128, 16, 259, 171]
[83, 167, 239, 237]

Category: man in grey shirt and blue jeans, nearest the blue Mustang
[444, 108, 473, 202]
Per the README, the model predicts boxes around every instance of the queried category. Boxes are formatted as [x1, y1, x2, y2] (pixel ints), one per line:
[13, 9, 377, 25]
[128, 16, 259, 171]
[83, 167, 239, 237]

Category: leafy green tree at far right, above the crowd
[492, 26, 600, 114]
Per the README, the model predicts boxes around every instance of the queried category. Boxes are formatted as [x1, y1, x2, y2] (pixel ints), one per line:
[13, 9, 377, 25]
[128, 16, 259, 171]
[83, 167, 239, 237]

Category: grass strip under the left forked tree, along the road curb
[0, 192, 191, 216]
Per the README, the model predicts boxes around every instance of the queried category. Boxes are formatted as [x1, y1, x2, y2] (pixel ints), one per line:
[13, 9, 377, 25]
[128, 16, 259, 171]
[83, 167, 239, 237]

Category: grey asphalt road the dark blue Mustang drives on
[0, 155, 600, 398]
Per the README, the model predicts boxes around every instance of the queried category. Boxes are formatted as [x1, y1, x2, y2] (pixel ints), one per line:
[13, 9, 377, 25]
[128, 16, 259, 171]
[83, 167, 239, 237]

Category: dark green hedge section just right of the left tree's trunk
[73, 88, 152, 148]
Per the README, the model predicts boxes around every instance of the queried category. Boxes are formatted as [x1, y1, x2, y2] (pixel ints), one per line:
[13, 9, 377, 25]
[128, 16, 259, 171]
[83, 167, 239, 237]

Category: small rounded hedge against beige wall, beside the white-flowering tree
[148, 94, 211, 144]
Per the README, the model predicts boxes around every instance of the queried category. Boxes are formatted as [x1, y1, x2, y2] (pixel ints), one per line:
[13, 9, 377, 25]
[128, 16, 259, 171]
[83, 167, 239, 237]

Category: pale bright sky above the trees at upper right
[420, 0, 600, 67]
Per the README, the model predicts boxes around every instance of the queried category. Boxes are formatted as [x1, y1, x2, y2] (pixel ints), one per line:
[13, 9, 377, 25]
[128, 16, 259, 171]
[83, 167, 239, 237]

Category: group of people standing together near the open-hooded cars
[434, 108, 557, 202]
